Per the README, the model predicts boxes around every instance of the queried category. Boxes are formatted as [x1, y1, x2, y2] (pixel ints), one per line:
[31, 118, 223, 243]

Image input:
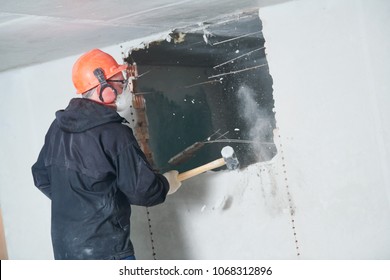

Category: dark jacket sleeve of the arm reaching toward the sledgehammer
[116, 143, 169, 206]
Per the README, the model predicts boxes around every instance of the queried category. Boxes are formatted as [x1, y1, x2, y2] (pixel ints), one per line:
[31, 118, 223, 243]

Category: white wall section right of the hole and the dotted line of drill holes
[260, 0, 390, 259]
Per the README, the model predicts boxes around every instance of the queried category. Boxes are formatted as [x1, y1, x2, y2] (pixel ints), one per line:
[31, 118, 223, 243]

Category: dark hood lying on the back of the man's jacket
[56, 98, 124, 133]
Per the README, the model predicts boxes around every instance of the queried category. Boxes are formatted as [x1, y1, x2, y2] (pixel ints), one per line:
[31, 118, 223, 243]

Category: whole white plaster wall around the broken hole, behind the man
[0, 0, 390, 259]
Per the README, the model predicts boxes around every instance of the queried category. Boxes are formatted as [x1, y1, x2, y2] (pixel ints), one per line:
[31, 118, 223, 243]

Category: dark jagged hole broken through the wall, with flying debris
[127, 13, 276, 171]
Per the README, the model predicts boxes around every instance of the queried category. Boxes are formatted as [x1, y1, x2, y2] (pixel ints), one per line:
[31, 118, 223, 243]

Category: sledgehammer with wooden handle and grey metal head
[177, 146, 240, 181]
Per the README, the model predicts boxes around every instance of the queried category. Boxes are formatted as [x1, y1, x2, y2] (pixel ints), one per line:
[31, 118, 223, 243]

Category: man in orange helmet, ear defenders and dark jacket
[32, 49, 181, 259]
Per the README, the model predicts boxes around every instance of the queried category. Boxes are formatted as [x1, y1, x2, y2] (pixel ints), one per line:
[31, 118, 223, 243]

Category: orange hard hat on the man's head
[72, 49, 127, 94]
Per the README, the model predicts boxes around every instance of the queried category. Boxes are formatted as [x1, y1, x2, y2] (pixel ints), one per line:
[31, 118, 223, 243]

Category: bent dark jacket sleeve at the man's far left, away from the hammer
[31, 145, 51, 199]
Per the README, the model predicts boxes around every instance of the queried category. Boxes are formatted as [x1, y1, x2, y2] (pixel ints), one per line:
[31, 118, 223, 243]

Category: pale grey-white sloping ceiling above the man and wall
[0, 0, 284, 72]
